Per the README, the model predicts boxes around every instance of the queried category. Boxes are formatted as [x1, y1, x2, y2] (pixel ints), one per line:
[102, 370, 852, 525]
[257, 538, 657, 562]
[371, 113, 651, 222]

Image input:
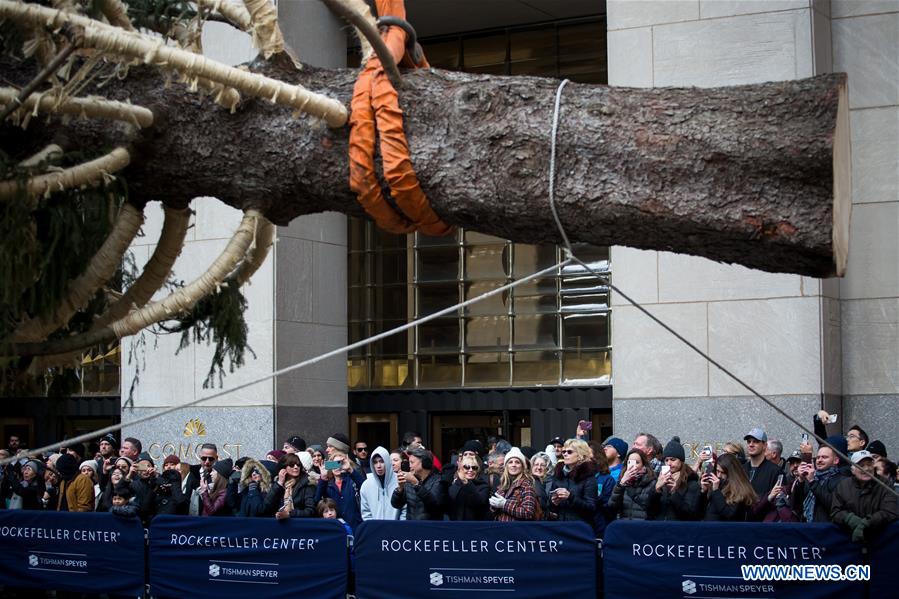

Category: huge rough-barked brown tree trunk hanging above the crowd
[7, 61, 851, 277]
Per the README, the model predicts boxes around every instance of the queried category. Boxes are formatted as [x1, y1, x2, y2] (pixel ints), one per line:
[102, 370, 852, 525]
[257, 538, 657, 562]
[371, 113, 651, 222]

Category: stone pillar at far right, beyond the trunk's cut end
[831, 0, 899, 452]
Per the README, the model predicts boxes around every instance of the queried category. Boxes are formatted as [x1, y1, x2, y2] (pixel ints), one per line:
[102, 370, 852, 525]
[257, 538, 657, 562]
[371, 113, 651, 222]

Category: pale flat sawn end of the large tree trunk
[833, 79, 852, 277]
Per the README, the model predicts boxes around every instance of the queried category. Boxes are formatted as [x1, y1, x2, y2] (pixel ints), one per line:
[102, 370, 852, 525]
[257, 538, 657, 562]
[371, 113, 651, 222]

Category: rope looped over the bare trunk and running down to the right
[549, 79, 899, 497]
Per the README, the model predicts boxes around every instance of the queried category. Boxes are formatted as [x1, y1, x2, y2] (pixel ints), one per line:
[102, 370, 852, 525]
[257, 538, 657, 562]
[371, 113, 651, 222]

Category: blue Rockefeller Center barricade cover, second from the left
[150, 516, 347, 599]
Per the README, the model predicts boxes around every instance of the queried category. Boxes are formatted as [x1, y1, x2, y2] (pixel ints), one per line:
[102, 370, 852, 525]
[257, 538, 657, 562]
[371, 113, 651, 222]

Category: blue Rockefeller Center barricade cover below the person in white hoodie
[355, 520, 596, 599]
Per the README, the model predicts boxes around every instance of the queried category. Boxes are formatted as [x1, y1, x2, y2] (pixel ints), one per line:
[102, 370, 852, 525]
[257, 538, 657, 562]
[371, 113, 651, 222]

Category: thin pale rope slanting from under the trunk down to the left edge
[0, 258, 571, 466]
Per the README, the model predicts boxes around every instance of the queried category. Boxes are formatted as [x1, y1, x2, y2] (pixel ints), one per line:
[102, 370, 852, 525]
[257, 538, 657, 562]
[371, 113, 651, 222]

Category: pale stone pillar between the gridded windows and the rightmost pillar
[607, 0, 841, 450]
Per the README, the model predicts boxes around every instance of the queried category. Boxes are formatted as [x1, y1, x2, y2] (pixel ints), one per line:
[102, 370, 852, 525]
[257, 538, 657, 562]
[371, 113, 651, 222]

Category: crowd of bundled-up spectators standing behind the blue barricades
[0, 411, 899, 542]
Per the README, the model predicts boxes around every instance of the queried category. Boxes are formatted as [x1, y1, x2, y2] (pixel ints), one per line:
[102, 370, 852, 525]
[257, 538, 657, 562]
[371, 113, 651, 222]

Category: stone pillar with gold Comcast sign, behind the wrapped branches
[122, 0, 347, 462]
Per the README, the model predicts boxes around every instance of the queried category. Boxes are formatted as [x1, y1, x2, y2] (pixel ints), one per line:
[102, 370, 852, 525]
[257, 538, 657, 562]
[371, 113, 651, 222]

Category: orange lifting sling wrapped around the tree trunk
[349, 0, 455, 236]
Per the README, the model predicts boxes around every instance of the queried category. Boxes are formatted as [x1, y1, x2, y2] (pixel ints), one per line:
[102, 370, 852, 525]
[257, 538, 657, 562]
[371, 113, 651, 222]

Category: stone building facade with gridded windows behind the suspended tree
[103, 0, 899, 464]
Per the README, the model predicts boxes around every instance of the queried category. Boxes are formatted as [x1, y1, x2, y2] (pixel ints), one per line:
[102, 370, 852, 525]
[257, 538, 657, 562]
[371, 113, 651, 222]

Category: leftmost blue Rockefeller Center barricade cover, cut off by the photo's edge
[0, 510, 144, 597]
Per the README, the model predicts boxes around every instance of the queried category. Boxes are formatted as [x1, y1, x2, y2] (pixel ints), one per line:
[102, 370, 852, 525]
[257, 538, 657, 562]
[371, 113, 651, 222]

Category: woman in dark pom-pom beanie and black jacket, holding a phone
[654, 437, 701, 520]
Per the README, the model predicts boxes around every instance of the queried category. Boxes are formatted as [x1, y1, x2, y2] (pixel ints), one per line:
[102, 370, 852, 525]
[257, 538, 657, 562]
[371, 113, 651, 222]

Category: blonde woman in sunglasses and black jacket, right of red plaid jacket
[548, 439, 596, 526]
